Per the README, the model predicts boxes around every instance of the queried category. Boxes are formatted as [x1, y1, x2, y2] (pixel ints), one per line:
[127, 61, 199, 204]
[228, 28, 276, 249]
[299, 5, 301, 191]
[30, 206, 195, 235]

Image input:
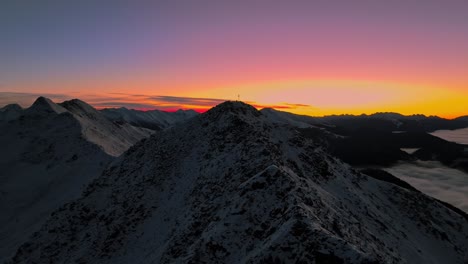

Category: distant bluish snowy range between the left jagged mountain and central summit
[101, 107, 198, 130]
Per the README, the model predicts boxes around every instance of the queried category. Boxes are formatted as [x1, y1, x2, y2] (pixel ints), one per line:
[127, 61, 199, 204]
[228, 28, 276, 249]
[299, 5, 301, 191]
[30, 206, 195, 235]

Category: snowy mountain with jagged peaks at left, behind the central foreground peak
[0, 97, 152, 263]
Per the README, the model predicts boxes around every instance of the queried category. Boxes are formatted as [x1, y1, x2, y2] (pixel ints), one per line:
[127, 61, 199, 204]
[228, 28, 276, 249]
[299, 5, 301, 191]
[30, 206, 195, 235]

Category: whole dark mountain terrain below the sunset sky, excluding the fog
[0, 98, 468, 263]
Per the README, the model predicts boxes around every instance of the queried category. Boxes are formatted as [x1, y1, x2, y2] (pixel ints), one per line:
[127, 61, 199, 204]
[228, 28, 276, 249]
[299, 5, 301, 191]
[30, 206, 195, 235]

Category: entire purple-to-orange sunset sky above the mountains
[0, 0, 468, 118]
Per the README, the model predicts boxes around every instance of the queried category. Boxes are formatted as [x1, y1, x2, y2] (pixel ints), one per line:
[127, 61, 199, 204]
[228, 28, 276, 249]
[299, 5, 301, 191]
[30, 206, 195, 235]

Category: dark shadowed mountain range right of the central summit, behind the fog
[261, 109, 468, 171]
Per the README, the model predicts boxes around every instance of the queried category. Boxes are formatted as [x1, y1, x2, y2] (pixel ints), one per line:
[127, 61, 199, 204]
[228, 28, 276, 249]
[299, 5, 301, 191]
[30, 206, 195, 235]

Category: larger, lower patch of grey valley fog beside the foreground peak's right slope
[385, 161, 468, 213]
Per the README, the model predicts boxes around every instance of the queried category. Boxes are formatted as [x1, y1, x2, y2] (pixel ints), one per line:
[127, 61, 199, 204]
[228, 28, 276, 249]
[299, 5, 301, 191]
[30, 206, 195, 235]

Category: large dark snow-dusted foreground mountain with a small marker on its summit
[11, 102, 468, 263]
